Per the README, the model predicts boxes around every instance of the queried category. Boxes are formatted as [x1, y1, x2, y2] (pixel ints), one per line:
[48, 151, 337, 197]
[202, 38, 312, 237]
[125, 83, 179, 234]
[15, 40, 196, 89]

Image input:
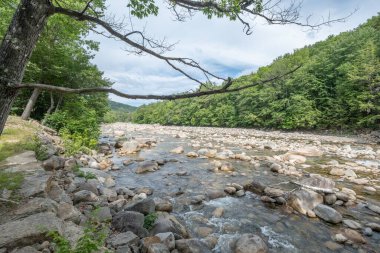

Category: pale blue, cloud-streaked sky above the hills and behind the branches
[89, 0, 380, 106]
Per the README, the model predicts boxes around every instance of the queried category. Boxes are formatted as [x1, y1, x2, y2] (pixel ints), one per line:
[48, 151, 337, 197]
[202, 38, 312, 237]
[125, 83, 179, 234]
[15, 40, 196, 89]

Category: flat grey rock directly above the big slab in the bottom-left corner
[14, 197, 58, 217]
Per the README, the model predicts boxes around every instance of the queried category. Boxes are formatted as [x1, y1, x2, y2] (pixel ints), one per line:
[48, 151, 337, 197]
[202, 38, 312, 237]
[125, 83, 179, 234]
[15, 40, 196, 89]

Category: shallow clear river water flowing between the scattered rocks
[101, 126, 380, 253]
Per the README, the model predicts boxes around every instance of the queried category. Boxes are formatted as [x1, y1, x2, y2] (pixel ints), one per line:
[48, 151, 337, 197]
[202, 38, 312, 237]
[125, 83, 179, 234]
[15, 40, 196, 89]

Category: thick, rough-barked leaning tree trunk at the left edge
[0, 0, 53, 134]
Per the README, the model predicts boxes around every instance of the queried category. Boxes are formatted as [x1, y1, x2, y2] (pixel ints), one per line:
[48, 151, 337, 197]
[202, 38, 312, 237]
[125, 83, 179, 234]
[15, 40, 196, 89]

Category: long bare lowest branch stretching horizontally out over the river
[9, 66, 301, 100]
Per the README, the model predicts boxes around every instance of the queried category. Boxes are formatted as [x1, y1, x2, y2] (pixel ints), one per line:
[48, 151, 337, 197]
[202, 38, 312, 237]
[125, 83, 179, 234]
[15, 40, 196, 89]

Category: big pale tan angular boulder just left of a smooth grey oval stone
[288, 189, 323, 214]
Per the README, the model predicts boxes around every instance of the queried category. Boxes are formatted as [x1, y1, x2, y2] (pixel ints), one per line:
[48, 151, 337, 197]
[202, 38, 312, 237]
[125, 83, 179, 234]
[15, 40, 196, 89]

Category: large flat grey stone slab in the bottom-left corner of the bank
[0, 212, 63, 248]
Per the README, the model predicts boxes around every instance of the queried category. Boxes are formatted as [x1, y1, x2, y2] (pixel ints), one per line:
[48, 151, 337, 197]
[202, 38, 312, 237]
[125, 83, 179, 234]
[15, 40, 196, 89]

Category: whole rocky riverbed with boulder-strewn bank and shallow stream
[0, 123, 380, 253]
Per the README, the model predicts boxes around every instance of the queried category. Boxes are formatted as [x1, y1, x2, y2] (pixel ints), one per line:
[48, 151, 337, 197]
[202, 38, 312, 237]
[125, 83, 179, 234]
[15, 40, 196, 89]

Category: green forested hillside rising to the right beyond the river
[133, 15, 380, 129]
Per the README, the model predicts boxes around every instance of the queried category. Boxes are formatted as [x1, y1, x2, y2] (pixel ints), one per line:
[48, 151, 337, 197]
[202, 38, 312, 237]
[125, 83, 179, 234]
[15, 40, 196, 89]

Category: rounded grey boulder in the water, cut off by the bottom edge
[235, 234, 268, 253]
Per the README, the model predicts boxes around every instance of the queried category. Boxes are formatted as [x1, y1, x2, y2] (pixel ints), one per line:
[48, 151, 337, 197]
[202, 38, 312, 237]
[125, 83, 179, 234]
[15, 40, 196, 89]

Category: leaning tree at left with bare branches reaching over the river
[0, 0, 350, 134]
